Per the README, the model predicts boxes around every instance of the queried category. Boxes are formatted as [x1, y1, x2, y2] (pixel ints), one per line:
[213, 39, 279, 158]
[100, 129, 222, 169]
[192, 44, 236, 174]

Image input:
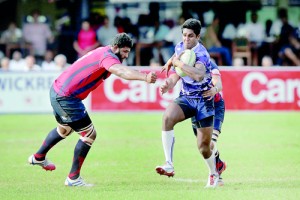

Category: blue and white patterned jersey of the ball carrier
[175, 42, 212, 98]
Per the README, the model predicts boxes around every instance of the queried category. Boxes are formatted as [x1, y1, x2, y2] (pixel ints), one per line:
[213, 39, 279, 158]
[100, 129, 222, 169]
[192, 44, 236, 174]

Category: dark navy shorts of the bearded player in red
[50, 87, 92, 131]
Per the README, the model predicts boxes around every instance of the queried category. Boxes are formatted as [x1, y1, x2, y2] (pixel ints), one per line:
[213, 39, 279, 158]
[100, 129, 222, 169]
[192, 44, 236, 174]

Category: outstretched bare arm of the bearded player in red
[108, 64, 157, 83]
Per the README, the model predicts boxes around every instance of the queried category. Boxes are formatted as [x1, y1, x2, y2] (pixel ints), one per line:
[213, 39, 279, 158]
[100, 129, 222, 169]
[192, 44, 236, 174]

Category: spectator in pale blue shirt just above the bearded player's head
[97, 16, 118, 46]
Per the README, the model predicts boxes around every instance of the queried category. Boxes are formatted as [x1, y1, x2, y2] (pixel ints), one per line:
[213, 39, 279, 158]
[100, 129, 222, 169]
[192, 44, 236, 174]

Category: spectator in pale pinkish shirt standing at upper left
[23, 10, 54, 62]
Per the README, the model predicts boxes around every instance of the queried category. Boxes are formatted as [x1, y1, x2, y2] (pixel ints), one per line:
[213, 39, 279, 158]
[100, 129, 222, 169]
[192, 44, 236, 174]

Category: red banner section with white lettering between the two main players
[91, 67, 180, 111]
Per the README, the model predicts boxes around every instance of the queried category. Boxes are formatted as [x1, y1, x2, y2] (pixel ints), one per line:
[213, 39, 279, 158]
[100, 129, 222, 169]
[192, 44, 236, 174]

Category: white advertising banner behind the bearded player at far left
[0, 72, 59, 113]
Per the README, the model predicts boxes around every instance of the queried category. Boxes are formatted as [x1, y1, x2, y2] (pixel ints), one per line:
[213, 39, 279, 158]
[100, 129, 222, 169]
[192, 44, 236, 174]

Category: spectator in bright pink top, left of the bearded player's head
[73, 20, 99, 57]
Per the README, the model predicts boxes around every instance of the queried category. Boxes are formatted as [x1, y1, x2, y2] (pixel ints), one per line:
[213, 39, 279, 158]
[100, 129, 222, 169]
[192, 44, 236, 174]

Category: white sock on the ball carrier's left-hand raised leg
[161, 130, 175, 164]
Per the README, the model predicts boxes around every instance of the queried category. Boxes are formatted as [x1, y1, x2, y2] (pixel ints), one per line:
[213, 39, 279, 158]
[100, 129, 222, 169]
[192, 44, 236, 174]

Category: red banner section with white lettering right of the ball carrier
[221, 67, 300, 111]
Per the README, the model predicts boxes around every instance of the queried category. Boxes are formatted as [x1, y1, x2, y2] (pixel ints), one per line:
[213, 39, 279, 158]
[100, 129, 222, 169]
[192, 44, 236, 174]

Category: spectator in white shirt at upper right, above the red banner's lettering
[245, 11, 265, 66]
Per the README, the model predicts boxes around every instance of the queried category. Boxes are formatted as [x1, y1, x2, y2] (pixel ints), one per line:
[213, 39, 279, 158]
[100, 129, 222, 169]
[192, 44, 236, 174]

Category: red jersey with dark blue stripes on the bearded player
[53, 46, 121, 100]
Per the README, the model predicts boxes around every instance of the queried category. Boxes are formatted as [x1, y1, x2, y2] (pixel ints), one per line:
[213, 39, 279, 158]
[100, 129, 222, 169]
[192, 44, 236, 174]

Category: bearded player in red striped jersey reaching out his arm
[28, 33, 157, 186]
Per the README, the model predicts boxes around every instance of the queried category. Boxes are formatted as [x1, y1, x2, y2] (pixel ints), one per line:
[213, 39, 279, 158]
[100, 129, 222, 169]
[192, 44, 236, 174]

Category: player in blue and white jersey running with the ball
[156, 19, 219, 188]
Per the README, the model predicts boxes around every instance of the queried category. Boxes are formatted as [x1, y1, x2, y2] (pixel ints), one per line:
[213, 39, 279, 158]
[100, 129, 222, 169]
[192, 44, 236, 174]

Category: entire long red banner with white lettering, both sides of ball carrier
[91, 67, 300, 111]
